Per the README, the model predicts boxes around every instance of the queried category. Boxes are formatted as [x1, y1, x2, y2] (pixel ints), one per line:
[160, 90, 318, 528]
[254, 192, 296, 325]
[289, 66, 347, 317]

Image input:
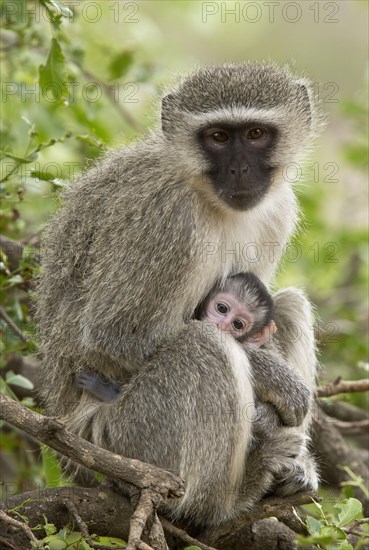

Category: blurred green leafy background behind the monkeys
[0, 0, 368, 500]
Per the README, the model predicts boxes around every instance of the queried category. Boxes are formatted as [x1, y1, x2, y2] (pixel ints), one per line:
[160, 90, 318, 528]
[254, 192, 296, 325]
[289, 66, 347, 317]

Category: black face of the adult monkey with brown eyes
[198, 123, 277, 210]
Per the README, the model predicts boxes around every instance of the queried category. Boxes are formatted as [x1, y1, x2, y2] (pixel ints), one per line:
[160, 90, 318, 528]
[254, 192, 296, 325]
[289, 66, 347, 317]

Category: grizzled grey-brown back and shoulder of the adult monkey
[37, 138, 205, 414]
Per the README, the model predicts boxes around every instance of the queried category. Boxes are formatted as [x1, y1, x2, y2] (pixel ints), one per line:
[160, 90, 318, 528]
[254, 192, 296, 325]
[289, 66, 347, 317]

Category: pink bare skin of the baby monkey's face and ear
[201, 292, 277, 347]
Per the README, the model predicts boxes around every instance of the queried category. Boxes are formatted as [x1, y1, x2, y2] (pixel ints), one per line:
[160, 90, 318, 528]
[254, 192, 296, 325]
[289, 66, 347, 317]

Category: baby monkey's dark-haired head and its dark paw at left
[76, 271, 277, 402]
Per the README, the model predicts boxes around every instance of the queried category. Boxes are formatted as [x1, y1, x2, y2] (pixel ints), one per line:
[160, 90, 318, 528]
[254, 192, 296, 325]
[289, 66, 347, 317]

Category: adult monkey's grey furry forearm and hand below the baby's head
[245, 347, 312, 426]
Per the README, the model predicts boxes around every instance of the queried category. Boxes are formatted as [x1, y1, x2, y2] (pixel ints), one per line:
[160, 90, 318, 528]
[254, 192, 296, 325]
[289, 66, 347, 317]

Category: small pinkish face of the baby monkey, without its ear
[201, 292, 255, 340]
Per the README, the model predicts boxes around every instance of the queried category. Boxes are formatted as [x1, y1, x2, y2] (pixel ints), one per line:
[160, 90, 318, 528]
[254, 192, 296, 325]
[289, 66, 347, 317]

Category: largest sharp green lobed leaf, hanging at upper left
[39, 38, 67, 101]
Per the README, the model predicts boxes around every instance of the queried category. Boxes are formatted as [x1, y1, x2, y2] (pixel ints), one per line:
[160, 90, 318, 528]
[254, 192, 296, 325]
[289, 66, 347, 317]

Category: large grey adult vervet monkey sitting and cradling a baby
[38, 63, 318, 523]
